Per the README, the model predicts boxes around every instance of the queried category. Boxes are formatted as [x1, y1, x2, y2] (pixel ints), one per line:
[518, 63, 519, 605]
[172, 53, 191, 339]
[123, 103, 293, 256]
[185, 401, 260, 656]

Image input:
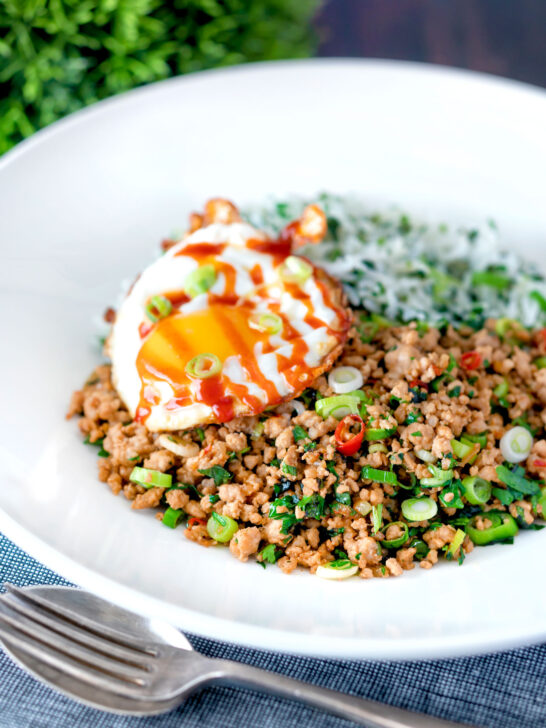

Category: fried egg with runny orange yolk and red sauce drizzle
[108, 202, 351, 432]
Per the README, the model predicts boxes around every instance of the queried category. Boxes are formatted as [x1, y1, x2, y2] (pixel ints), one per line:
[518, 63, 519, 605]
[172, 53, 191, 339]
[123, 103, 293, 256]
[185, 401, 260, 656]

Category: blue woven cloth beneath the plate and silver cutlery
[0, 534, 546, 728]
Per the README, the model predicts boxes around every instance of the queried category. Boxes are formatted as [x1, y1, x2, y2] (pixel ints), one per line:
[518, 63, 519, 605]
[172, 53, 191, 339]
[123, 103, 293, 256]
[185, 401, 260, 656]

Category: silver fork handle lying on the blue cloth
[209, 660, 461, 728]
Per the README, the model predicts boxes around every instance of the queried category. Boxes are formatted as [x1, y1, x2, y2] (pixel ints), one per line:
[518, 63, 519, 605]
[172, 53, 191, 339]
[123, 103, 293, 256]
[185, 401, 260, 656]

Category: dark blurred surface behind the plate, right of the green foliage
[317, 0, 546, 86]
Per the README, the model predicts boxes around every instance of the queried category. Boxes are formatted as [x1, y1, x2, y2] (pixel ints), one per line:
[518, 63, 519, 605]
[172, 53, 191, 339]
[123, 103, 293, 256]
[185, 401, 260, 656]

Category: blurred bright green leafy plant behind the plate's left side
[0, 0, 319, 153]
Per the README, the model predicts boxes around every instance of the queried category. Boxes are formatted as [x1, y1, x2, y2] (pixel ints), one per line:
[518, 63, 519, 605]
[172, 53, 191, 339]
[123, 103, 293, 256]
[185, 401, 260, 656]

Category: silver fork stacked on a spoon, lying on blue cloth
[0, 584, 470, 728]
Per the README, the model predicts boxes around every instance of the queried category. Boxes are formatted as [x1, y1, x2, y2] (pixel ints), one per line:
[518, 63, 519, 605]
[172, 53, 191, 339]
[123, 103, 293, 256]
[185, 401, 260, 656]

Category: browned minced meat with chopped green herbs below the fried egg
[68, 321, 546, 578]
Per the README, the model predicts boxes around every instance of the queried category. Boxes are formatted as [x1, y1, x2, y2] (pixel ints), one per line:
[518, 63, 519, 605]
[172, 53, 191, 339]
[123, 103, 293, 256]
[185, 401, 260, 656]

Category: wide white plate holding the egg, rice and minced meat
[0, 61, 546, 658]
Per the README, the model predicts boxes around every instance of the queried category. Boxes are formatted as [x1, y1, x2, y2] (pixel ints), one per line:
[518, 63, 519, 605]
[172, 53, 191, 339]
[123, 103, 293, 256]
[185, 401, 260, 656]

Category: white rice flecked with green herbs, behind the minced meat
[243, 193, 546, 328]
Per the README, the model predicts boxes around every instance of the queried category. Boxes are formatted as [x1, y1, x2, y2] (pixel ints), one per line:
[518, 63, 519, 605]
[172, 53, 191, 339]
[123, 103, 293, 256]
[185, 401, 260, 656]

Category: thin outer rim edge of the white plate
[0, 58, 546, 660]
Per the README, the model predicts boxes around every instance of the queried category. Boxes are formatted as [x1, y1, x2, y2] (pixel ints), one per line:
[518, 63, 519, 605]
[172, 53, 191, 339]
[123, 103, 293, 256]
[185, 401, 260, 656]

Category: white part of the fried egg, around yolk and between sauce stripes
[108, 223, 337, 432]
